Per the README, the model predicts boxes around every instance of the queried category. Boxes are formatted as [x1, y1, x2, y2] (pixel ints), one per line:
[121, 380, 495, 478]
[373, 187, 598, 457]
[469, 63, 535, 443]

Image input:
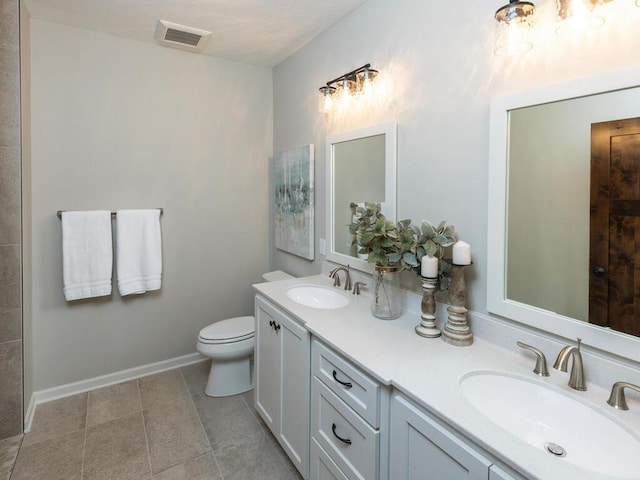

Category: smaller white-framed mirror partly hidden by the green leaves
[327, 122, 396, 273]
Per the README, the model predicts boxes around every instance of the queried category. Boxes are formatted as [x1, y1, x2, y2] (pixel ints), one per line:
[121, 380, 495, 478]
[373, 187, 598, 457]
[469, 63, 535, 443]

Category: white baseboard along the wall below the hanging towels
[24, 352, 206, 433]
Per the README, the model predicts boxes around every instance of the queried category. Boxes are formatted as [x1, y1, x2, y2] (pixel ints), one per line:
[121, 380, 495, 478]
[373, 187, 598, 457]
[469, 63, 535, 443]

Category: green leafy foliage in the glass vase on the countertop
[349, 202, 456, 289]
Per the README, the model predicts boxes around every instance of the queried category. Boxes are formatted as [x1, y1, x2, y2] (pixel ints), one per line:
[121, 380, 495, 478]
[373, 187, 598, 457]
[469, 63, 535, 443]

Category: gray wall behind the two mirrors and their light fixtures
[272, 0, 640, 312]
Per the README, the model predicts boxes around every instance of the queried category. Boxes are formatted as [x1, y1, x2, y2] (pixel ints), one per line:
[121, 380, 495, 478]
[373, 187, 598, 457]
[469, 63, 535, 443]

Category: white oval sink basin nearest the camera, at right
[460, 372, 640, 479]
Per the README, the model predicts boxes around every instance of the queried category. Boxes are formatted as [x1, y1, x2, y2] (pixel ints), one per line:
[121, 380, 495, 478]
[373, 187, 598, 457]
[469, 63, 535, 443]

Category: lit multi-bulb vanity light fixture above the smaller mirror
[318, 63, 378, 113]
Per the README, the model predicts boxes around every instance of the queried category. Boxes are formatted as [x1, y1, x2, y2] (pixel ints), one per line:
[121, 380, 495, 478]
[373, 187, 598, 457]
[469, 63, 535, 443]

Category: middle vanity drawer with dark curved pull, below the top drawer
[311, 377, 380, 480]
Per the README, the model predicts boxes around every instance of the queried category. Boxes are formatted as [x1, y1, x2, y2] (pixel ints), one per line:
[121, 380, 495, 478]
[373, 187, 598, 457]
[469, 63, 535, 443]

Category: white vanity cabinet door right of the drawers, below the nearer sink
[389, 393, 492, 480]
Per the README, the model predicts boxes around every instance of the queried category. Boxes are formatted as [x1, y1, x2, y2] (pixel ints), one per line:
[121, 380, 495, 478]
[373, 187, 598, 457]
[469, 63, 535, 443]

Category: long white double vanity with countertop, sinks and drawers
[254, 274, 640, 480]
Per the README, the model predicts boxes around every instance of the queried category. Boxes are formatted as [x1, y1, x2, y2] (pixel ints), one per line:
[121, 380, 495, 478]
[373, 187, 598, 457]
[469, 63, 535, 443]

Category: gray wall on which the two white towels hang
[30, 19, 273, 391]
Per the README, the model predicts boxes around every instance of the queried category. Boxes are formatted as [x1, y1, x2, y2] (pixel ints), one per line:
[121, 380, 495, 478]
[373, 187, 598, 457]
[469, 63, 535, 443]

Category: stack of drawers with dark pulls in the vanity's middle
[310, 339, 388, 480]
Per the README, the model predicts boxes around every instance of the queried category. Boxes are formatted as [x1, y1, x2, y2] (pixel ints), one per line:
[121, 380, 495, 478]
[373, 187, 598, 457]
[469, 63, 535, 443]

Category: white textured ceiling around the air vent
[25, 0, 366, 67]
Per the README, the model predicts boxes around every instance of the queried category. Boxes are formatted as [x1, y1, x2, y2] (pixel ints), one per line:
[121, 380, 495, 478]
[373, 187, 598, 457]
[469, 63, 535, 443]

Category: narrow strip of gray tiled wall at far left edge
[0, 0, 22, 439]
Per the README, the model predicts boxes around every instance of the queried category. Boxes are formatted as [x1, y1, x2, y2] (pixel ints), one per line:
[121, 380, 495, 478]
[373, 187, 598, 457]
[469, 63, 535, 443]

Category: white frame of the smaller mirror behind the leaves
[326, 122, 397, 273]
